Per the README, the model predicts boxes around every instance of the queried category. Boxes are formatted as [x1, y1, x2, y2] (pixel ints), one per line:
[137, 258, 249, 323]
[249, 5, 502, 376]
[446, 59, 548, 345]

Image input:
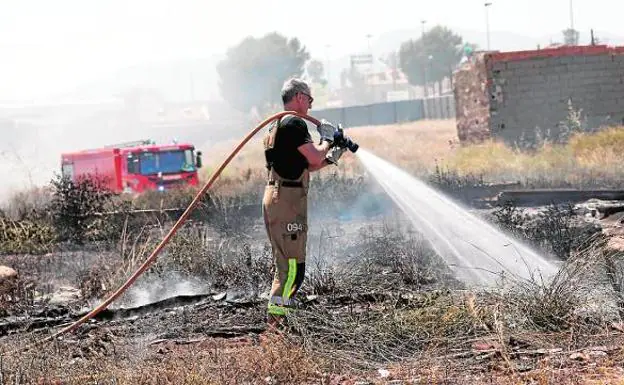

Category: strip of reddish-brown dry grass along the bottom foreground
[6, 335, 623, 385]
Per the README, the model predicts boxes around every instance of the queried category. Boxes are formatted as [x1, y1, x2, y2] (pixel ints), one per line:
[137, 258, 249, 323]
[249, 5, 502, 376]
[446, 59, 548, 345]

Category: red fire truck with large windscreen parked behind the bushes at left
[61, 140, 202, 193]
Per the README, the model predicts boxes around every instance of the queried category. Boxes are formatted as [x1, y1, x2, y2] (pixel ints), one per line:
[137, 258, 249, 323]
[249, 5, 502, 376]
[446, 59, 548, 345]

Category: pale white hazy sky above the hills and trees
[0, 0, 624, 100]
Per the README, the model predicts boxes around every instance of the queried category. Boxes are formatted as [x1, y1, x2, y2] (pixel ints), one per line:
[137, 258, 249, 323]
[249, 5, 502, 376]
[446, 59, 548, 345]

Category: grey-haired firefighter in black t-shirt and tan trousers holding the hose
[262, 78, 345, 326]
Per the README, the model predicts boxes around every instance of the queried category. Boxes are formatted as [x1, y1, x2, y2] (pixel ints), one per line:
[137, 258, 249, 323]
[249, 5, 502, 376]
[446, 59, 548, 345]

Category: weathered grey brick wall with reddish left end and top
[454, 46, 624, 145]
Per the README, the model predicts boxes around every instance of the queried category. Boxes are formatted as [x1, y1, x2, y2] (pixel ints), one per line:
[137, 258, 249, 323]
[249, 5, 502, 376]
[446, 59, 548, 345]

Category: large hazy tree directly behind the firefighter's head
[217, 32, 310, 112]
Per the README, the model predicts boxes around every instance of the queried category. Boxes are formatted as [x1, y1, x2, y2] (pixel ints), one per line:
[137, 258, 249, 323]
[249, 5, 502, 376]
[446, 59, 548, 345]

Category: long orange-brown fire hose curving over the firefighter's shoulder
[0, 111, 332, 357]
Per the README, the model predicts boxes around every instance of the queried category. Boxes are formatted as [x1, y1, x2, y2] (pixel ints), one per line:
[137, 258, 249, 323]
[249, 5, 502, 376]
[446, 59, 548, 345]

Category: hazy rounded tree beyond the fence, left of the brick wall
[399, 26, 464, 89]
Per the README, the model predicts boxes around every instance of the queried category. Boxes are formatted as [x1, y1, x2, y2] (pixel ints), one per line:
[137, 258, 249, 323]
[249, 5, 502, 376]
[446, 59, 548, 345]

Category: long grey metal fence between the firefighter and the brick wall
[313, 95, 455, 127]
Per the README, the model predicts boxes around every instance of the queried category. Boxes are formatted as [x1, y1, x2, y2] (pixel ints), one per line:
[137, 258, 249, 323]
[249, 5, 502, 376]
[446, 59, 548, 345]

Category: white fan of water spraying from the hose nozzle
[358, 150, 558, 287]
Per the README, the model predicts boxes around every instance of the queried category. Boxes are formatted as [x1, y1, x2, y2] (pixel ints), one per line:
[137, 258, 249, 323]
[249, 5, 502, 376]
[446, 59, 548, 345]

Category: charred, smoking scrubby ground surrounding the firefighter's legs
[0, 121, 624, 384]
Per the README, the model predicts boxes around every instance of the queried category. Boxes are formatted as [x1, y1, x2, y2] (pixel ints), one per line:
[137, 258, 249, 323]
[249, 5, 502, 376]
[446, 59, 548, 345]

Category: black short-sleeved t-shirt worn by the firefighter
[273, 116, 312, 179]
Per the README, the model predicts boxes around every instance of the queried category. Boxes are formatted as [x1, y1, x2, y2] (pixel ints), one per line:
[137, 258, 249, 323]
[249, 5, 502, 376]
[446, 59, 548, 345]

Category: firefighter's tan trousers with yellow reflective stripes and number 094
[262, 170, 310, 316]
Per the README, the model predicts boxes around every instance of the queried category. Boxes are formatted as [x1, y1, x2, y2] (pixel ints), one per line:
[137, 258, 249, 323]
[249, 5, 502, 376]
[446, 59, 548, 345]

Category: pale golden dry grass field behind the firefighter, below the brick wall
[197, 120, 624, 190]
